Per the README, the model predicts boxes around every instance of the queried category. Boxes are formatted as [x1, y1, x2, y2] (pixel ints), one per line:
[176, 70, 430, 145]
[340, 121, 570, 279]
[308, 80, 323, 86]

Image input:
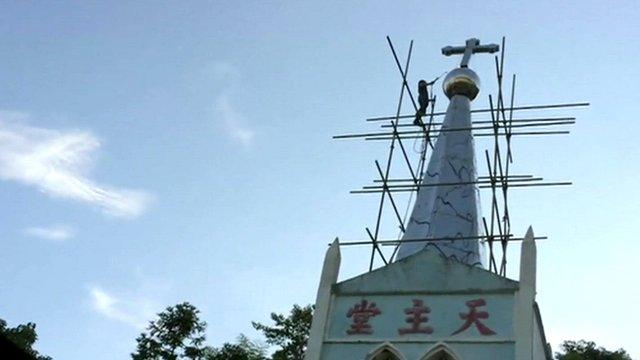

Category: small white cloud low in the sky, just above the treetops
[89, 286, 158, 329]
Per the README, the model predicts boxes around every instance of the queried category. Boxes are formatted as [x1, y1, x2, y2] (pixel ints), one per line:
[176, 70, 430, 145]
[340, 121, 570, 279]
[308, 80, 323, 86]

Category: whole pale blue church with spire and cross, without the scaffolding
[305, 39, 552, 360]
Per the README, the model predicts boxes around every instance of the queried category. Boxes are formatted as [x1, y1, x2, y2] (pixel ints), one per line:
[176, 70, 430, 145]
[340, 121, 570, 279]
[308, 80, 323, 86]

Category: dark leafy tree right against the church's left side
[251, 305, 313, 360]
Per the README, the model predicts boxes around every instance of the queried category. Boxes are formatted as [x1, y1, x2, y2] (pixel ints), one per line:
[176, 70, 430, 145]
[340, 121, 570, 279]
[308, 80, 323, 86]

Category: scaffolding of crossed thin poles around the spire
[333, 36, 589, 276]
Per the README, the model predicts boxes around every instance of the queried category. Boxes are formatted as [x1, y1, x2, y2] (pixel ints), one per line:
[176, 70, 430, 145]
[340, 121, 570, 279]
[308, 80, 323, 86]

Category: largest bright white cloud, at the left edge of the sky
[0, 112, 151, 218]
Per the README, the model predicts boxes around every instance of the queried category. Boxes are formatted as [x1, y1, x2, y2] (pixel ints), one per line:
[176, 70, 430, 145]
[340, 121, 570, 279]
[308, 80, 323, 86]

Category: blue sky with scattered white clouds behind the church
[0, 0, 640, 360]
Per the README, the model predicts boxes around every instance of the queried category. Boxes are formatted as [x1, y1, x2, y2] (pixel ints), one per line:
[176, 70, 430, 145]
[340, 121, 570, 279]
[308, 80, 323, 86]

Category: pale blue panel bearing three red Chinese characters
[331, 295, 513, 339]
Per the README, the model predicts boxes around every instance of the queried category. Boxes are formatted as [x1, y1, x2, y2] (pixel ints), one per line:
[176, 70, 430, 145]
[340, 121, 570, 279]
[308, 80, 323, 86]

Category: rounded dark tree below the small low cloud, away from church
[131, 302, 207, 360]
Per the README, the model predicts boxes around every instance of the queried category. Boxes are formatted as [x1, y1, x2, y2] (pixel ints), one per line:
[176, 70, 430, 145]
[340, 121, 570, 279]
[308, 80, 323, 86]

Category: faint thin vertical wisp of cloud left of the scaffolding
[207, 62, 255, 146]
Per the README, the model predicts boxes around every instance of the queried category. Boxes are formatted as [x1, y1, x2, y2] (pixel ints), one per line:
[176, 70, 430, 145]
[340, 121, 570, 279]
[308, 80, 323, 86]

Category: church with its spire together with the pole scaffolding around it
[305, 38, 587, 360]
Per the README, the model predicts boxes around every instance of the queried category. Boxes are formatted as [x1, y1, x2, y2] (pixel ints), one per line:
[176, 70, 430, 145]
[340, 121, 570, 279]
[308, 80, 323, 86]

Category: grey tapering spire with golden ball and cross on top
[397, 39, 498, 265]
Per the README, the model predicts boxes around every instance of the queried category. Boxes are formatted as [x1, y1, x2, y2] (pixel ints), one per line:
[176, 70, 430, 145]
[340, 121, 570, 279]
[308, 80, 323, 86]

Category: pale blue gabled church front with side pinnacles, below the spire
[305, 229, 552, 360]
